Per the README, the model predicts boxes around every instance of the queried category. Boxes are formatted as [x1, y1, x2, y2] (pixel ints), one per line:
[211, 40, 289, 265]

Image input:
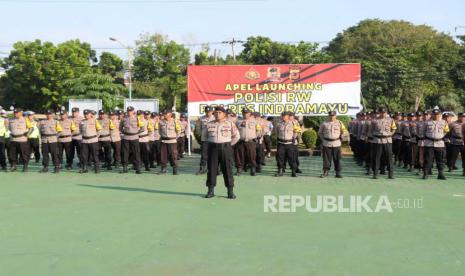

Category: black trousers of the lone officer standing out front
[206, 143, 234, 187]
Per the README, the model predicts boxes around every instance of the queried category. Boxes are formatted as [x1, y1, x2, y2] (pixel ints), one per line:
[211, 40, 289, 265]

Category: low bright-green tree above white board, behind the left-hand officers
[63, 73, 126, 110]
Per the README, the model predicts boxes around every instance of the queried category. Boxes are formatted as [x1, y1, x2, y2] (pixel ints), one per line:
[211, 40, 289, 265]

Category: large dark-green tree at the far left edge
[0, 40, 96, 110]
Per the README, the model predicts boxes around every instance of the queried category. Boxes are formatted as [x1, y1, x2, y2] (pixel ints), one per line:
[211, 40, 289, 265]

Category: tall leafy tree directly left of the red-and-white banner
[134, 34, 190, 110]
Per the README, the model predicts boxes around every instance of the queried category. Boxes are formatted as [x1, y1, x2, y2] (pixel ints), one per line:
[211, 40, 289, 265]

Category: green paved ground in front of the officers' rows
[0, 157, 465, 275]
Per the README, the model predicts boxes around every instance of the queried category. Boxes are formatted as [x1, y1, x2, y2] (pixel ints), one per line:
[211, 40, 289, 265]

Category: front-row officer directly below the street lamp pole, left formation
[120, 106, 144, 174]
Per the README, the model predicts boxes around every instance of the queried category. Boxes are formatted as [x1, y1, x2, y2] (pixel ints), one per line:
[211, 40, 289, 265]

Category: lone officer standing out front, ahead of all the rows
[203, 106, 239, 199]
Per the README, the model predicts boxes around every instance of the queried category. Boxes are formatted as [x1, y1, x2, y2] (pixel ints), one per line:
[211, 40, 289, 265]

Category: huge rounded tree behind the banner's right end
[325, 19, 461, 111]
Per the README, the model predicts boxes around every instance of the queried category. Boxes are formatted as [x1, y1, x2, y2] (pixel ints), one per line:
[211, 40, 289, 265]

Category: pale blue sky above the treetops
[0, 0, 465, 58]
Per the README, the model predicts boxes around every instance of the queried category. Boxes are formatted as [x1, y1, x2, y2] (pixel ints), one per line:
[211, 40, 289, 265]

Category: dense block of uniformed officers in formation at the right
[348, 108, 465, 180]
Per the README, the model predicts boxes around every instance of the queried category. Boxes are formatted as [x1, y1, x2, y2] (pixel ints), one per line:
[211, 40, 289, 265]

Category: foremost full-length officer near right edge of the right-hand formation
[423, 109, 449, 180]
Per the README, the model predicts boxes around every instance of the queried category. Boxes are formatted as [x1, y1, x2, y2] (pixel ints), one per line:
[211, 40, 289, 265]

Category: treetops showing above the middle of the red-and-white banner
[239, 36, 330, 64]
